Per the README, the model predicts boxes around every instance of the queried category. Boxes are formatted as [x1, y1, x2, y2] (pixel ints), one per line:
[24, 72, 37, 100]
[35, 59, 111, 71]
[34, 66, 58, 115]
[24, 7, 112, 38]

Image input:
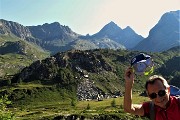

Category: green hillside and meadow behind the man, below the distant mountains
[0, 48, 180, 120]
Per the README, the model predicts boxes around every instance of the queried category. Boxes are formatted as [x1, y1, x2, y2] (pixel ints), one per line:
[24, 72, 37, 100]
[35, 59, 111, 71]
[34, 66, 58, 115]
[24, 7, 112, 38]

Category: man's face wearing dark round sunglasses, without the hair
[147, 80, 170, 108]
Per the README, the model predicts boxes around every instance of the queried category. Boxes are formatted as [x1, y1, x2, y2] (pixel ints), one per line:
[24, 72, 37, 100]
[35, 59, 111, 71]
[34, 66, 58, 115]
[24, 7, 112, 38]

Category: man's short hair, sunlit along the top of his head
[145, 75, 170, 91]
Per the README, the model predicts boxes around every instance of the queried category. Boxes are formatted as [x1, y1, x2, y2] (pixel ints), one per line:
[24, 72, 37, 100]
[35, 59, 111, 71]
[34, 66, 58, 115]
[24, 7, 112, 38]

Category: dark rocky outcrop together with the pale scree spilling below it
[13, 50, 119, 100]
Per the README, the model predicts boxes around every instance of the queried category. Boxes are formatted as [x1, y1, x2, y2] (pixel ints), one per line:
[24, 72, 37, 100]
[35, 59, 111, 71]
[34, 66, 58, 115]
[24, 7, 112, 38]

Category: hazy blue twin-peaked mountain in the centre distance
[82, 21, 143, 49]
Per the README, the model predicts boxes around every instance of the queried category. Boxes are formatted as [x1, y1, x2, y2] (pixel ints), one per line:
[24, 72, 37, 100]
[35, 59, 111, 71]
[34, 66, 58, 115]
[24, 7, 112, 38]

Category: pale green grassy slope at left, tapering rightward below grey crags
[0, 35, 49, 77]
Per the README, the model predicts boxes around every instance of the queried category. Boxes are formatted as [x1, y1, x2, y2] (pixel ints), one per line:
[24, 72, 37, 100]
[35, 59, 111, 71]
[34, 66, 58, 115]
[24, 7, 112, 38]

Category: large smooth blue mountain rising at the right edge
[133, 10, 180, 52]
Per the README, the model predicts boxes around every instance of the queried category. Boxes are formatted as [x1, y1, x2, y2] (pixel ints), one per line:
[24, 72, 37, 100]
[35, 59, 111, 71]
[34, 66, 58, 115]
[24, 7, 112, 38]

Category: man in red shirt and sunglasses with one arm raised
[124, 68, 180, 120]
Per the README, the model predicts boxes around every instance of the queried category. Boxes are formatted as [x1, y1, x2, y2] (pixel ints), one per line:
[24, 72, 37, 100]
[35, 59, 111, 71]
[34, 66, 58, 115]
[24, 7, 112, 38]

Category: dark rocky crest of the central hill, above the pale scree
[18, 50, 113, 81]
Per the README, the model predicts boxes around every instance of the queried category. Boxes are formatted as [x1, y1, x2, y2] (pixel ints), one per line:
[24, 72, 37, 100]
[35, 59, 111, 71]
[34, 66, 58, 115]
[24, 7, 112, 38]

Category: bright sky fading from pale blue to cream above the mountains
[0, 0, 180, 37]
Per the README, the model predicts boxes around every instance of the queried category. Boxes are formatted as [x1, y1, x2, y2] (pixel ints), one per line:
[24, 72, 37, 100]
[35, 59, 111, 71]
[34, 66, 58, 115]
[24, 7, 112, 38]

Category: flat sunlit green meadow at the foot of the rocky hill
[12, 94, 148, 120]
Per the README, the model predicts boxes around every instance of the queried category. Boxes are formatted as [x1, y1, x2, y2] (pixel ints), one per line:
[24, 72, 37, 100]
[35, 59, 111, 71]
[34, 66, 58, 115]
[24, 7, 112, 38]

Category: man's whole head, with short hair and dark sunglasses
[145, 75, 170, 108]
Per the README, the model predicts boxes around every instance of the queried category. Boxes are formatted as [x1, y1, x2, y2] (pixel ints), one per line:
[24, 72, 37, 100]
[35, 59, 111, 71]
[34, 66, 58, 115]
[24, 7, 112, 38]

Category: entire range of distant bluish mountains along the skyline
[0, 10, 180, 54]
